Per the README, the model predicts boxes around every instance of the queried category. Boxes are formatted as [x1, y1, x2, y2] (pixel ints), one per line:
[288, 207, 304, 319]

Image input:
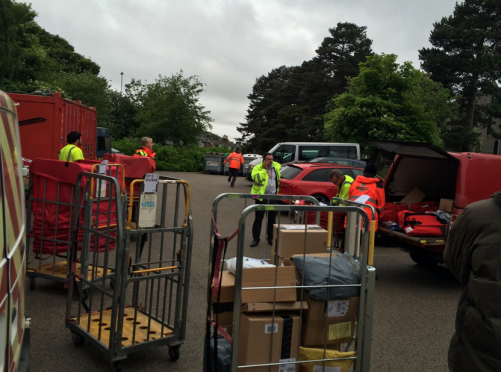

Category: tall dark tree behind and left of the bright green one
[237, 23, 372, 152]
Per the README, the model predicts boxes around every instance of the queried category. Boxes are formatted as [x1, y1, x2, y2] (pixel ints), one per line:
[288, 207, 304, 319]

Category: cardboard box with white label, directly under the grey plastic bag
[301, 291, 358, 348]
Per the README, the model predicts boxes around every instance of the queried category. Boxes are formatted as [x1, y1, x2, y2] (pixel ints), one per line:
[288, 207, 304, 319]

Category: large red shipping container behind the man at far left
[9, 92, 97, 159]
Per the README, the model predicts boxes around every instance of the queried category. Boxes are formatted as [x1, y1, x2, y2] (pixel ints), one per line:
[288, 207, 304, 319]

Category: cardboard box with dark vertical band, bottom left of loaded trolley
[238, 314, 300, 372]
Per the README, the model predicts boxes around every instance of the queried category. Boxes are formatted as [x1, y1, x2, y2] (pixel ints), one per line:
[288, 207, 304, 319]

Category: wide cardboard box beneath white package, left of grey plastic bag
[212, 266, 297, 303]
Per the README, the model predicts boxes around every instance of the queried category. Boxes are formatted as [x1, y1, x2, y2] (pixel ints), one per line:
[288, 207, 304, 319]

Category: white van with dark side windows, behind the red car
[247, 142, 360, 181]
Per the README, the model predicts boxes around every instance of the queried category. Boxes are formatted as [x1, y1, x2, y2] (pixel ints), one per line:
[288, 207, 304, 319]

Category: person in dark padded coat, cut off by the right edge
[444, 192, 501, 372]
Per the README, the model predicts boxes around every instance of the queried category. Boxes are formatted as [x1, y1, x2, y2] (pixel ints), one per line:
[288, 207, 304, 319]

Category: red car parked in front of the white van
[278, 163, 379, 204]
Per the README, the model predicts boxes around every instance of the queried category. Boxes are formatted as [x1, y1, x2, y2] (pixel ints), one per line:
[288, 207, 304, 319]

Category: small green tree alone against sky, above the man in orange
[126, 71, 213, 145]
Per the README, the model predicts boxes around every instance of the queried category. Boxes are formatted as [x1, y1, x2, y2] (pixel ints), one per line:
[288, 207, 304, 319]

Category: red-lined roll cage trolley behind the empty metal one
[26, 163, 125, 290]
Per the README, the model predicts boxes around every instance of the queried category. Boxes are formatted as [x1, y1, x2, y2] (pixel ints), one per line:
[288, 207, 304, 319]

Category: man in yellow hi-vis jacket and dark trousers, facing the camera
[251, 153, 280, 247]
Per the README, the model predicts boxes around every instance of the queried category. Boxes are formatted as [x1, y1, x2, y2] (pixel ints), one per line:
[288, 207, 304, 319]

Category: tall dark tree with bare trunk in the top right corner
[419, 0, 501, 151]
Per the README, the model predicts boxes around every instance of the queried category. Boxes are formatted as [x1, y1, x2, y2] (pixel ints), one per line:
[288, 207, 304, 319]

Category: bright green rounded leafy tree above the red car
[325, 54, 457, 155]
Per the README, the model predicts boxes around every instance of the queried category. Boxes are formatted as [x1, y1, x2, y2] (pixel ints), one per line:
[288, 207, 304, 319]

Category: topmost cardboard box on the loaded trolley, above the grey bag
[272, 224, 328, 258]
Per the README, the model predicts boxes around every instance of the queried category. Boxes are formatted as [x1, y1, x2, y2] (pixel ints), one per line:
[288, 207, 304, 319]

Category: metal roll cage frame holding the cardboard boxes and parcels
[203, 194, 376, 372]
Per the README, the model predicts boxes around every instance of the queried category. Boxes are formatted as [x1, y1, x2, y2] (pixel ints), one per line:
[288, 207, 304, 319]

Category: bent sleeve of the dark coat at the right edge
[444, 208, 476, 285]
